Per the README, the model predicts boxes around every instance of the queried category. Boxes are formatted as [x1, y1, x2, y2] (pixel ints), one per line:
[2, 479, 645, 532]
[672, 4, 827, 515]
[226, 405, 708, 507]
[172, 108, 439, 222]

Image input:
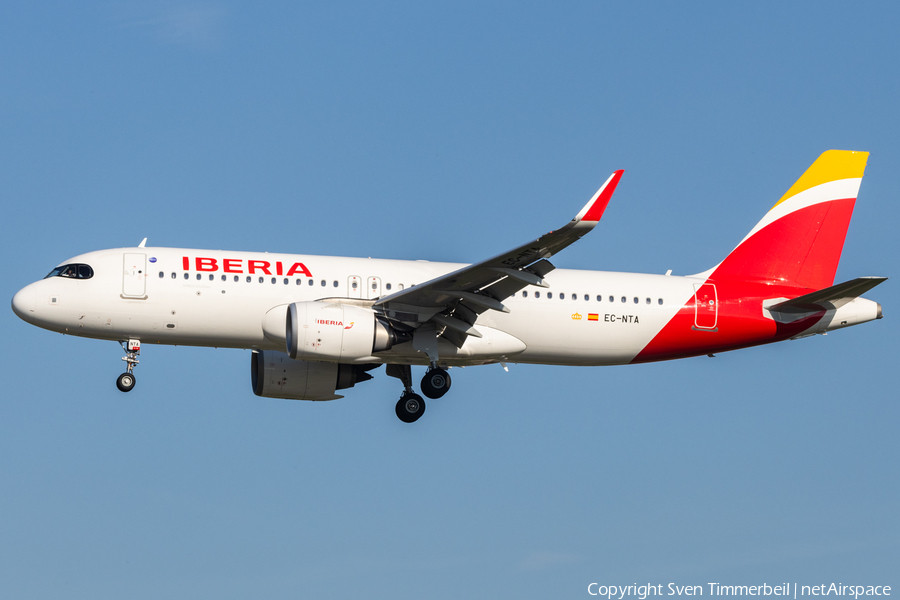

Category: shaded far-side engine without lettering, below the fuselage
[250, 350, 381, 400]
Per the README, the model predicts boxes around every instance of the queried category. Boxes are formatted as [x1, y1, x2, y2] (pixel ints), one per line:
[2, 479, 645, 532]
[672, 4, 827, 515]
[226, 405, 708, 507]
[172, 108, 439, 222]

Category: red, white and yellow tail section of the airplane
[634, 150, 884, 362]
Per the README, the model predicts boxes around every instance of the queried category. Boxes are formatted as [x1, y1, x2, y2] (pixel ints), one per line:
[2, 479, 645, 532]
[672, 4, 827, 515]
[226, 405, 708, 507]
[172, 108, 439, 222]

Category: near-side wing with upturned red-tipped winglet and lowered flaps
[375, 171, 623, 356]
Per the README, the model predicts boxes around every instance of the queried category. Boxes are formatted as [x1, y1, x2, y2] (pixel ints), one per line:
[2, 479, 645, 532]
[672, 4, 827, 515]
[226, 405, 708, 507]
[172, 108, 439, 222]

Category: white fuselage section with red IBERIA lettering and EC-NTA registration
[13, 248, 702, 366]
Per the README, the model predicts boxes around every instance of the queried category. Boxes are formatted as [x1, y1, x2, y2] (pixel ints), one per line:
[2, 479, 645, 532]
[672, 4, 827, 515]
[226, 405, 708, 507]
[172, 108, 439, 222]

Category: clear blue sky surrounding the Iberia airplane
[0, 1, 900, 599]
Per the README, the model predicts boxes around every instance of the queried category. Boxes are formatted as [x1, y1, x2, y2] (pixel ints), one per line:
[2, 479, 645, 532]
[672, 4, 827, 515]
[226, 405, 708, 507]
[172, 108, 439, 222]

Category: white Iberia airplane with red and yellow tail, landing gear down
[12, 150, 886, 423]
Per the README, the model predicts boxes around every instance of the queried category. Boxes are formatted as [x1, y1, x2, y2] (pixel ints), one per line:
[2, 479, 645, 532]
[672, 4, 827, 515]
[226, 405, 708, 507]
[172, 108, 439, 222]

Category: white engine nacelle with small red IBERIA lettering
[285, 302, 401, 362]
